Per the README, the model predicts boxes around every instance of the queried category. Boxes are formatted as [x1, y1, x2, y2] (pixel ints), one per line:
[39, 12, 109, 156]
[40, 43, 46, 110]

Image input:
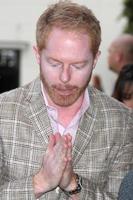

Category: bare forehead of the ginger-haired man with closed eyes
[46, 28, 91, 57]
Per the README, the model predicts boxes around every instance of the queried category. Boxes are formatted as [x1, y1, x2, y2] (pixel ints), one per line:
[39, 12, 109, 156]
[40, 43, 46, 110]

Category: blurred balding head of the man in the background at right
[108, 34, 133, 73]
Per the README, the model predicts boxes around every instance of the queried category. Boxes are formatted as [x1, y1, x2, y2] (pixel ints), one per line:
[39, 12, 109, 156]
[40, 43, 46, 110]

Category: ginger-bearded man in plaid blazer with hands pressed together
[0, 1, 133, 200]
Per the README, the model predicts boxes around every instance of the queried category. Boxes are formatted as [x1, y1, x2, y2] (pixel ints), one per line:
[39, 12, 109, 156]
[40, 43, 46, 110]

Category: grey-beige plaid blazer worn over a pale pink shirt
[0, 79, 133, 200]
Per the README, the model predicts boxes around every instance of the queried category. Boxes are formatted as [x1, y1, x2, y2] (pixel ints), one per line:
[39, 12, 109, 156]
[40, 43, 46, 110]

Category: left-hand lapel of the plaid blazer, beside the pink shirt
[26, 81, 52, 144]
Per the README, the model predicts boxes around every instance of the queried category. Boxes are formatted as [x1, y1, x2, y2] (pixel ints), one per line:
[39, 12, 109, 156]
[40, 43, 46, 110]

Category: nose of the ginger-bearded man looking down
[60, 66, 71, 83]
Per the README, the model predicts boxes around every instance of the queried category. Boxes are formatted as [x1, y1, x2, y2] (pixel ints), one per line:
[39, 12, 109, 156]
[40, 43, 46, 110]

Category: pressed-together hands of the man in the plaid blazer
[33, 133, 76, 198]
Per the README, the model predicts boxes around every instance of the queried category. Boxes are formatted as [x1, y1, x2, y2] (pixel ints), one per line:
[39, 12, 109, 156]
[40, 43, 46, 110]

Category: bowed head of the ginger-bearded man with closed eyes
[36, 1, 101, 106]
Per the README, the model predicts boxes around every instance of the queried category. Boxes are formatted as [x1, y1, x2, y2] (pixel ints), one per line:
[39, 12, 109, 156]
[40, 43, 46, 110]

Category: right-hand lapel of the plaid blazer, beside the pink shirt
[73, 87, 98, 166]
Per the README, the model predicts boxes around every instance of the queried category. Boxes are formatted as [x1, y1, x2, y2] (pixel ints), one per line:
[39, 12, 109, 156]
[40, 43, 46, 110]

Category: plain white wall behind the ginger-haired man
[0, 0, 125, 94]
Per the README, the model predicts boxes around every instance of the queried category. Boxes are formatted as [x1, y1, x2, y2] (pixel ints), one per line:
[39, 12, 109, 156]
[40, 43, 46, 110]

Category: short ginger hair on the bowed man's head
[36, 0, 101, 56]
